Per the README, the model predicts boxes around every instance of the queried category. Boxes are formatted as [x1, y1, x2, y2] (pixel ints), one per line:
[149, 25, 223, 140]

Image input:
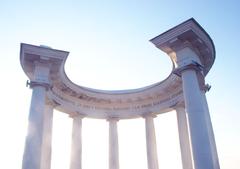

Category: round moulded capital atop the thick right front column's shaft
[173, 61, 203, 77]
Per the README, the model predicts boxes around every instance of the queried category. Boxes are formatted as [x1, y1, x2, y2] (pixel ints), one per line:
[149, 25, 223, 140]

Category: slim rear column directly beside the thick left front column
[41, 104, 53, 169]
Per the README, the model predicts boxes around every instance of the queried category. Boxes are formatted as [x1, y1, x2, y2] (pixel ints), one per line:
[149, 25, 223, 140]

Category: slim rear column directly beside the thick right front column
[176, 107, 193, 169]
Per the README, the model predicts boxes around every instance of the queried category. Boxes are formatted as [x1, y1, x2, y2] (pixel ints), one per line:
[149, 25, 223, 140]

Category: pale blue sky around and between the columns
[0, 0, 240, 169]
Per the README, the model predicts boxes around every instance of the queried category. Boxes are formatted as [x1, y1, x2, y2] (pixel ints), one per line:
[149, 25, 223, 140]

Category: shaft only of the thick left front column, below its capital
[22, 86, 46, 169]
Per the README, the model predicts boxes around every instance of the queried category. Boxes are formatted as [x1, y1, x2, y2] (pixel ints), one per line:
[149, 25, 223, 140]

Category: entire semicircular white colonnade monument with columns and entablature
[20, 19, 220, 169]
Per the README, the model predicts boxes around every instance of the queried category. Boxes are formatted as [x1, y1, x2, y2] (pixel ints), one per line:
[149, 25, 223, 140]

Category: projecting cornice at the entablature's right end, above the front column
[150, 18, 215, 75]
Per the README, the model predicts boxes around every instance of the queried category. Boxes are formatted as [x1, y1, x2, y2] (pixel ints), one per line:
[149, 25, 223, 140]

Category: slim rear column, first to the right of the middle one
[144, 114, 158, 169]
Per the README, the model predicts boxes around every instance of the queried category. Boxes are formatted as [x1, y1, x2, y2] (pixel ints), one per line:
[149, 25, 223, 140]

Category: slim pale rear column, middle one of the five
[108, 118, 119, 169]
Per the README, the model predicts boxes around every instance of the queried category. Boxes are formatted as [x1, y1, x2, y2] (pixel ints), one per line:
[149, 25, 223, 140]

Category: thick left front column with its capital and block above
[22, 62, 49, 169]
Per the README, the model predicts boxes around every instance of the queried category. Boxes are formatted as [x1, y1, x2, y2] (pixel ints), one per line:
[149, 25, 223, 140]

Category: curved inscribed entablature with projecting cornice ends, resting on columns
[20, 19, 215, 119]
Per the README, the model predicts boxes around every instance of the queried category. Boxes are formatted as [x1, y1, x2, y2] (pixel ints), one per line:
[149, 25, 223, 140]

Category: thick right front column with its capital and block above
[175, 44, 217, 169]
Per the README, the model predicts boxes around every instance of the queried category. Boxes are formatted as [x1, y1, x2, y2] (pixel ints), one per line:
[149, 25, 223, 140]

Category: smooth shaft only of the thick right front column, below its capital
[181, 67, 214, 169]
